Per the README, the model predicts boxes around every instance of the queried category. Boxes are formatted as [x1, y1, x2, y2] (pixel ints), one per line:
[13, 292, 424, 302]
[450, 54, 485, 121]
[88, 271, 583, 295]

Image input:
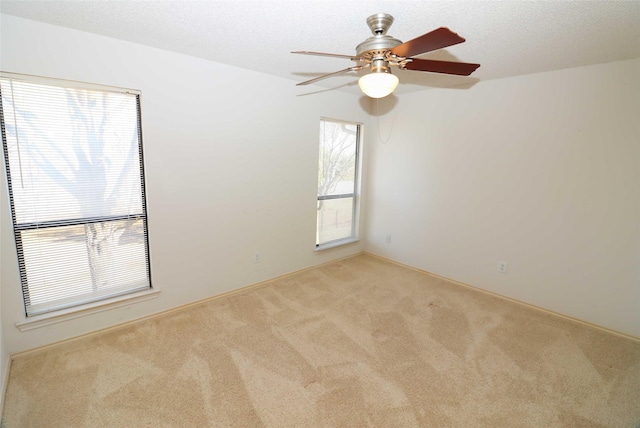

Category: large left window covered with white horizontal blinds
[0, 73, 151, 316]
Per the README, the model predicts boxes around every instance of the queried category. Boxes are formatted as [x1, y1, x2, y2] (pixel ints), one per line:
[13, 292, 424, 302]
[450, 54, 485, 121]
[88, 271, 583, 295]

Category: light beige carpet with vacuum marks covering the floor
[3, 255, 640, 428]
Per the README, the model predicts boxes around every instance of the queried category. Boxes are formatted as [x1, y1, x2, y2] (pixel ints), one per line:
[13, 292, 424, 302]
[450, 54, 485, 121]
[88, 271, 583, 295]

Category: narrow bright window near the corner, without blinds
[316, 119, 360, 248]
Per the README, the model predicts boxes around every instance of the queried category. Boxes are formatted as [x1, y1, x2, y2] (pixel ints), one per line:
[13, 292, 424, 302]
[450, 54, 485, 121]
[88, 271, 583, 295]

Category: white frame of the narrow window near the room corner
[315, 117, 363, 251]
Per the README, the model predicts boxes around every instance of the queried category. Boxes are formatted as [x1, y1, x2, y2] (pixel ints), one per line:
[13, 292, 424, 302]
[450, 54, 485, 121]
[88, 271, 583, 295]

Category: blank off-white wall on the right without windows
[365, 59, 640, 337]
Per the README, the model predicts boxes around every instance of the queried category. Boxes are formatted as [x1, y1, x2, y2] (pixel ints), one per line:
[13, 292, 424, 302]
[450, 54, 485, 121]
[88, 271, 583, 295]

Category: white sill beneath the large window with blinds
[16, 289, 160, 331]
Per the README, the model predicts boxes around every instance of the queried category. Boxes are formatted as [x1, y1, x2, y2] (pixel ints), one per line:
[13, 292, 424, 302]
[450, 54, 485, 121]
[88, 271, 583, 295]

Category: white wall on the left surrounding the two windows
[0, 16, 368, 352]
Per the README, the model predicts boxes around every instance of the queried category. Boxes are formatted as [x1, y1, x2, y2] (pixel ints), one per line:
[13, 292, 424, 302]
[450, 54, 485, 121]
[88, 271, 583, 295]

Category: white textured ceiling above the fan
[0, 0, 640, 94]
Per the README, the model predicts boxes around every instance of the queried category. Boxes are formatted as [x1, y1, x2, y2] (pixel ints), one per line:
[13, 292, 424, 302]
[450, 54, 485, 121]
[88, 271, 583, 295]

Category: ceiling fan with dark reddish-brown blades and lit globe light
[291, 13, 480, 98]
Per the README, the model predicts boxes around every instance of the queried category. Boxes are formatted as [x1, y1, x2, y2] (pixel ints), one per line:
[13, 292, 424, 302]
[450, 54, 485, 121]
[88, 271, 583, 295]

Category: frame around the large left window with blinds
[0, 71, 153, 318]
